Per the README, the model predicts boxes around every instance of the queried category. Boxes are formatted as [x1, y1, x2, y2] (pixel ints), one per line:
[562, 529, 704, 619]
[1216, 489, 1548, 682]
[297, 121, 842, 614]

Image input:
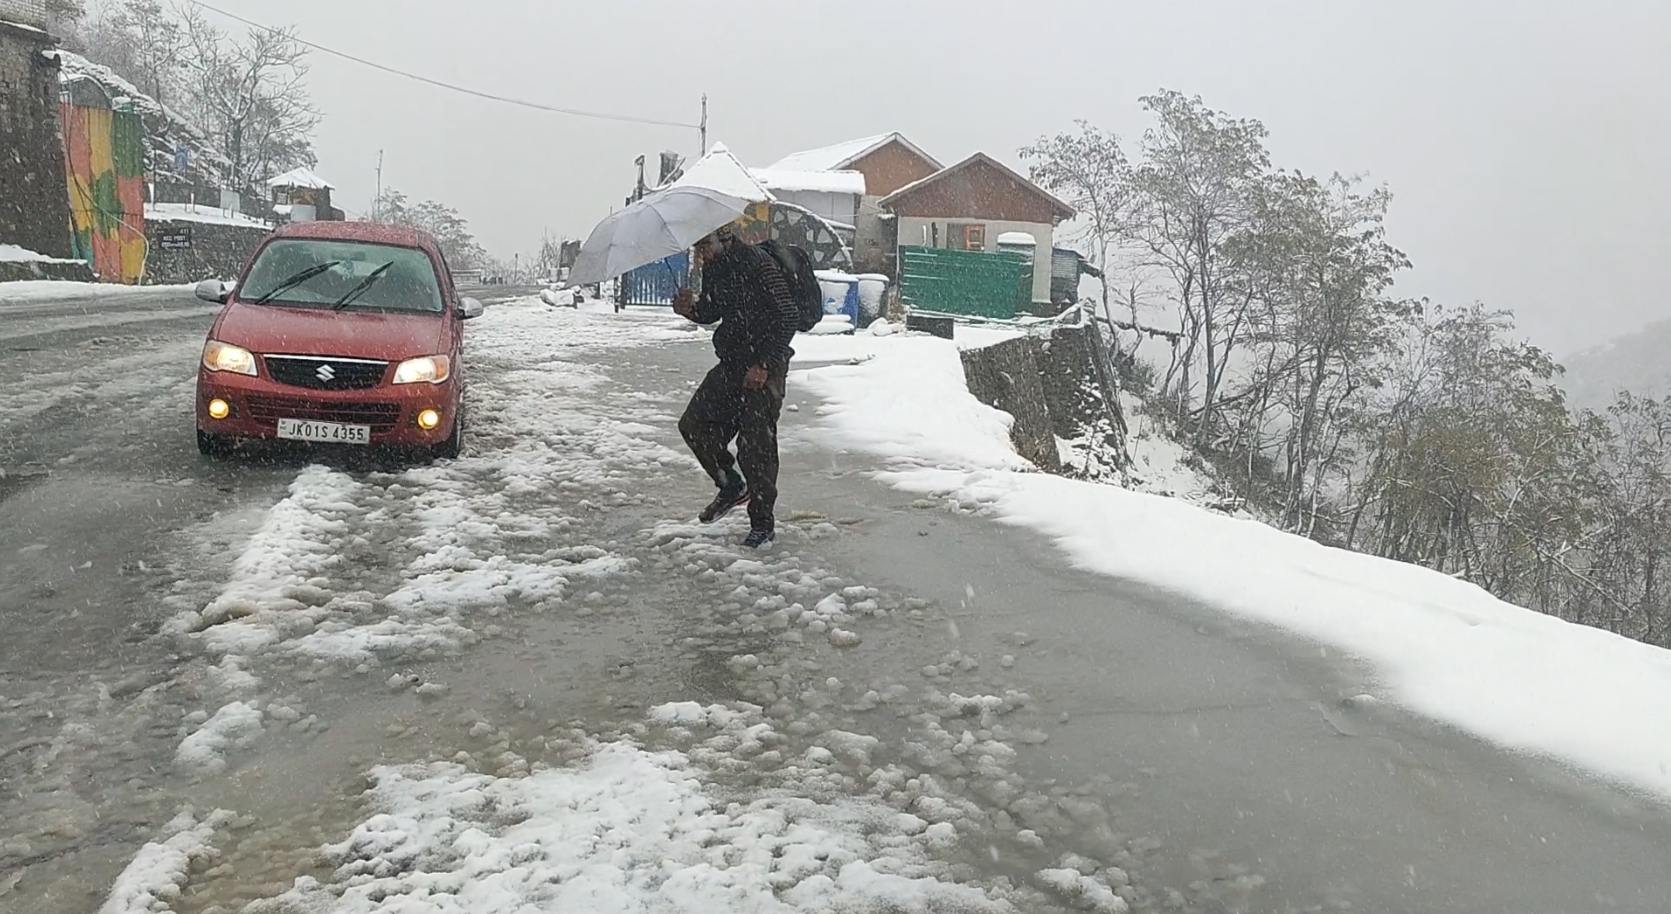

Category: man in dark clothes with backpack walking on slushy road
[673, 227, 799, 548]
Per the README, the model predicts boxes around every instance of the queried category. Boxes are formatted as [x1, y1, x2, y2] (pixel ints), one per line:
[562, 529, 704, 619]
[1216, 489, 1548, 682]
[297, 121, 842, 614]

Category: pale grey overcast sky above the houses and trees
[217, 0, 1671, 353]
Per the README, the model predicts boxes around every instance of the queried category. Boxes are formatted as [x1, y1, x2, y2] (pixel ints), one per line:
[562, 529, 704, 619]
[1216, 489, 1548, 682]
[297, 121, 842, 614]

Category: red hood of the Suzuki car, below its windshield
[214, 302, 446, 361]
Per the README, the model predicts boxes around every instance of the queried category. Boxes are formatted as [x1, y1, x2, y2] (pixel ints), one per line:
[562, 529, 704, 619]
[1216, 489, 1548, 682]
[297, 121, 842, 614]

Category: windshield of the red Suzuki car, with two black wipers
[237, 239, 441, 314]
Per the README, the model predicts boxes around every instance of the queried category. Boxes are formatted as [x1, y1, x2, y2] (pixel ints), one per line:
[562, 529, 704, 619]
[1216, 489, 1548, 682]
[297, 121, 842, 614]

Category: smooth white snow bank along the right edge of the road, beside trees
[795, 327, 1671, 797]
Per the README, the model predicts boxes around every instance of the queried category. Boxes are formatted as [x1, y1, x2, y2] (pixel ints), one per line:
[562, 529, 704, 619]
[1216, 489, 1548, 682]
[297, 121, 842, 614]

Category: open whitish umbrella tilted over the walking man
[568, 144, 772, 286]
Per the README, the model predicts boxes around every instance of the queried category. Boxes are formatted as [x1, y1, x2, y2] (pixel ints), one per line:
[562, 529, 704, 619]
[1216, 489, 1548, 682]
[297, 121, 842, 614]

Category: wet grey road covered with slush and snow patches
[0, 290, 1671, 914]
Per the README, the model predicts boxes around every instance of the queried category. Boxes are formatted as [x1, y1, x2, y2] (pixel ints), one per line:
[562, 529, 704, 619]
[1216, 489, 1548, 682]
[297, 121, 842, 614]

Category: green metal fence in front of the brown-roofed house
[899, 247, 1033, 321]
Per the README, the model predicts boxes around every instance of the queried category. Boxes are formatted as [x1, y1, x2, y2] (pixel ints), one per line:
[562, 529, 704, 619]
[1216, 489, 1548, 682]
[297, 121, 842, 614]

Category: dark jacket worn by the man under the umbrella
[695, 241, 800, 371]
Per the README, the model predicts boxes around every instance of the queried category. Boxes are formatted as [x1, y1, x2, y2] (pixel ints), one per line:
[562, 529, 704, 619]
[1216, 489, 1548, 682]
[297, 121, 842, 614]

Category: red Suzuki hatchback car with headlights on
[197, 222, 481, 456]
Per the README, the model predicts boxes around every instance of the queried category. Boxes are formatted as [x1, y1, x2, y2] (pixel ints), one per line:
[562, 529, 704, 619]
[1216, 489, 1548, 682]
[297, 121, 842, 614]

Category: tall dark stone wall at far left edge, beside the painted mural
[0, 17, 70, 257]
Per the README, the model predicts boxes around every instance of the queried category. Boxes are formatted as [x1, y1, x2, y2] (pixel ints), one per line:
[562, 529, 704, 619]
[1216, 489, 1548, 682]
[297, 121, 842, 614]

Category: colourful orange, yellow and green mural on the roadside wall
[62, 104, 145, 282]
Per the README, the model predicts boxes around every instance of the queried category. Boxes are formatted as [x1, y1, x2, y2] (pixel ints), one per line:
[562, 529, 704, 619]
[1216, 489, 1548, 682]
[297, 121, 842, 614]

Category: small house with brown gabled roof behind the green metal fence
[877, 152, 1074, 302]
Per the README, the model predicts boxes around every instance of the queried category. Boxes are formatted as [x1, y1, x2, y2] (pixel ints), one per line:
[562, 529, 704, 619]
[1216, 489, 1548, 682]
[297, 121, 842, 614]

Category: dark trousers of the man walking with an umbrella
[678, 363, 789, 530]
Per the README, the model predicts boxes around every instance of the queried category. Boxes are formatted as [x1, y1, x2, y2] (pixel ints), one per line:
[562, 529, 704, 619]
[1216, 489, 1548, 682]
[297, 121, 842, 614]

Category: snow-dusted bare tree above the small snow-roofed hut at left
[177, 7, 319, 190]
